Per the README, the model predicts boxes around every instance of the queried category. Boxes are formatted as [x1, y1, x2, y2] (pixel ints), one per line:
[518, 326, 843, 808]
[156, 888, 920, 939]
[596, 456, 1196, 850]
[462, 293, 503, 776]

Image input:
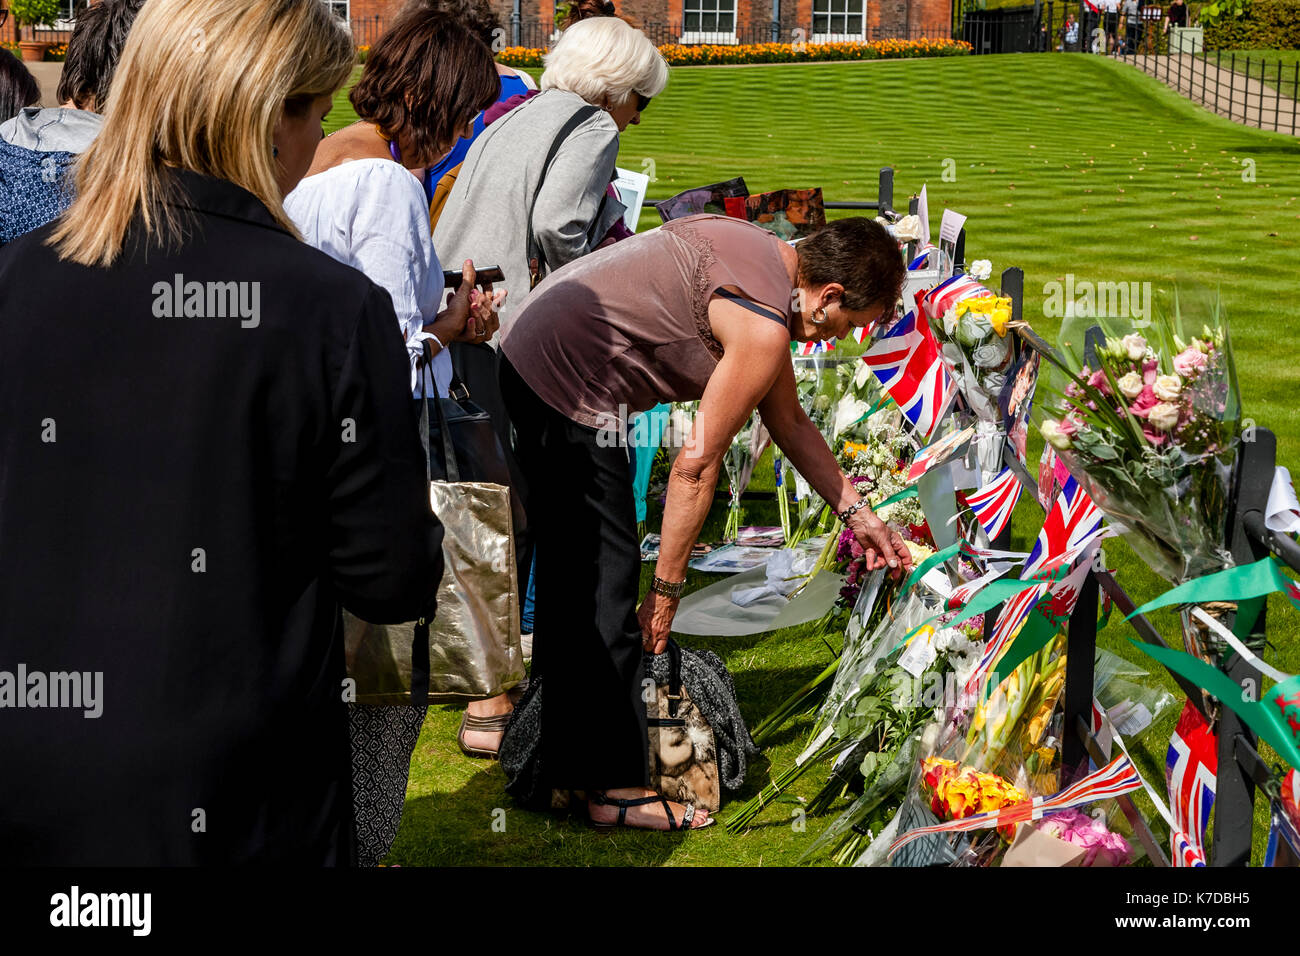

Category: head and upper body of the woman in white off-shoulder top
[285, 12, 504, 395]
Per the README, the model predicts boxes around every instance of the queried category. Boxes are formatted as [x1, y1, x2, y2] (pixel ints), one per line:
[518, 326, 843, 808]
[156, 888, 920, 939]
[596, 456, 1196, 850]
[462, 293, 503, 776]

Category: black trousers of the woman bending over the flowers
[501, 356, 649, 790]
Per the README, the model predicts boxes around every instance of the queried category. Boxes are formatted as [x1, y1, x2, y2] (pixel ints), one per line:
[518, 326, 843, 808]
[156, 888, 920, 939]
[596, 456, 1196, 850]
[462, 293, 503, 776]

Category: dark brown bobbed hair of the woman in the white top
[348, 4, 501, 164]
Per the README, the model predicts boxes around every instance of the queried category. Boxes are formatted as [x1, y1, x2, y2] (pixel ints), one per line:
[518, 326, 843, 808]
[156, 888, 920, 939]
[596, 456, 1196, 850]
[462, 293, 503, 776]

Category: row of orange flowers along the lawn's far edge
[497, 40, 971, 66]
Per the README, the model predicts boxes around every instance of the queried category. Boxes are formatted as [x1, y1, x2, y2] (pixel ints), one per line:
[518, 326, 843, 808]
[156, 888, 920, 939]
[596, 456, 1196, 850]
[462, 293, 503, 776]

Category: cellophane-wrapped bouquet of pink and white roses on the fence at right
[1035, 310, 1242, 584]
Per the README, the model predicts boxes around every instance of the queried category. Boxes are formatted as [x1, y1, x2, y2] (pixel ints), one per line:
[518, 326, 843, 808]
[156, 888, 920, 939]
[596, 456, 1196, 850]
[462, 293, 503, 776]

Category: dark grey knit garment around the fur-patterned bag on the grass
[498, 648, 758, 806]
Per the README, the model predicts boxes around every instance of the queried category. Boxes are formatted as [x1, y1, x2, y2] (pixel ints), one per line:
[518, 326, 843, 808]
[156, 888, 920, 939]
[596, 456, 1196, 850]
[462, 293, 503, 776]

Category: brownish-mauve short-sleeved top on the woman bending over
[501, 216, 793, 428]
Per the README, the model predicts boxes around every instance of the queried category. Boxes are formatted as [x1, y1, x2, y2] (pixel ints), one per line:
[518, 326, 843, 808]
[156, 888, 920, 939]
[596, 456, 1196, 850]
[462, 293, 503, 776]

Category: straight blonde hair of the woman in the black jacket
[49, 0, 356, 265]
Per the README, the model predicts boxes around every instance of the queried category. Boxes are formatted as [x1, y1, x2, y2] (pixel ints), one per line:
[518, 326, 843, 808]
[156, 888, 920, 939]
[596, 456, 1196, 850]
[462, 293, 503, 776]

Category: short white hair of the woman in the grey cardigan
[542, 17, 668, 105]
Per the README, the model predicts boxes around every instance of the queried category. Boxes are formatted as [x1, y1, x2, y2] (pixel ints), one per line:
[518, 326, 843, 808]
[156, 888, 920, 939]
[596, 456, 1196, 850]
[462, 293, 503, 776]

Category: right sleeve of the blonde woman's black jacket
[329, 280, 442, 624]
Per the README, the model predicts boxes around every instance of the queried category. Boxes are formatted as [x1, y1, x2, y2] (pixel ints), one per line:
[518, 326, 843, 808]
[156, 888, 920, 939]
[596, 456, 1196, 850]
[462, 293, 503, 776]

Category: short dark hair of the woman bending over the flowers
[794, 216, 906, 312]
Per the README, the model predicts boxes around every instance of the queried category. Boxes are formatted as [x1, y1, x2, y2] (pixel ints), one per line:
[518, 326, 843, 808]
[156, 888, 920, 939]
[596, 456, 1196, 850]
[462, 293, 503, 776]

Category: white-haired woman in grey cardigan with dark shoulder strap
[433, 17, 668, 756]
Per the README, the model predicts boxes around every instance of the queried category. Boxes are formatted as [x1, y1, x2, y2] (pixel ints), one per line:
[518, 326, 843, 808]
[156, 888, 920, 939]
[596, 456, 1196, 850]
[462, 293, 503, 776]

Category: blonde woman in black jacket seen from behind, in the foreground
[0, 0, 442, 865]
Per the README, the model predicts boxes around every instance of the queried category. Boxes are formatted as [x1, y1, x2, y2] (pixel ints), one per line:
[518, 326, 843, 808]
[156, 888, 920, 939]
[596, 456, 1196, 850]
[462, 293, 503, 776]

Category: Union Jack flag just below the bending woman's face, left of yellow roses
[862, 311, 957, 438]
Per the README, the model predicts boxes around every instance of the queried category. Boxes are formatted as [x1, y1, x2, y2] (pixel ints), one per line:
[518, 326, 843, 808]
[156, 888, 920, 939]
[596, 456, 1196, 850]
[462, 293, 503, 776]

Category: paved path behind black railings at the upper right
[1121, 53, 1300, 134]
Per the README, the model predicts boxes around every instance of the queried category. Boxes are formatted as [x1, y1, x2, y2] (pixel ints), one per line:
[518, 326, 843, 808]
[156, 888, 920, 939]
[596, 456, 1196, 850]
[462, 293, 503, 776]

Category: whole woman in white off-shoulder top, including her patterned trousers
[285, 7, 510, 866]
